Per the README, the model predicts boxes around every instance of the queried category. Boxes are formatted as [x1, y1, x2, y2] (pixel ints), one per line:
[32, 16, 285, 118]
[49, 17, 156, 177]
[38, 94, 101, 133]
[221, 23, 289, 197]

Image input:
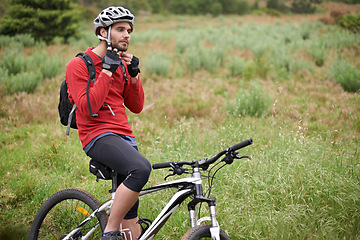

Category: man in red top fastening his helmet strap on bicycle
[66, 7, 151, 240]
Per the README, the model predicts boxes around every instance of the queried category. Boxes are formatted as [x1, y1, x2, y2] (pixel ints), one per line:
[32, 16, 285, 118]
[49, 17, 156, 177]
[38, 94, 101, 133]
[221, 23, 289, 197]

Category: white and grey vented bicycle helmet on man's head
[94, 6, 135, 36]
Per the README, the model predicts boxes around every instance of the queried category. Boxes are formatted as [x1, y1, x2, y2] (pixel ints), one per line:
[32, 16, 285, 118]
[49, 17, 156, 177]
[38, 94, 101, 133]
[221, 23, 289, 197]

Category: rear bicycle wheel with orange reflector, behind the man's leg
[29, 189, 108, 240]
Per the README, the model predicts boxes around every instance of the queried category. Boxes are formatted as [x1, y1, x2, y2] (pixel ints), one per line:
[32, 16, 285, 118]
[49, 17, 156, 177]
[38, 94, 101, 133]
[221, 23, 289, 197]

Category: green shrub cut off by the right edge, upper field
[328, 59, 360, 92]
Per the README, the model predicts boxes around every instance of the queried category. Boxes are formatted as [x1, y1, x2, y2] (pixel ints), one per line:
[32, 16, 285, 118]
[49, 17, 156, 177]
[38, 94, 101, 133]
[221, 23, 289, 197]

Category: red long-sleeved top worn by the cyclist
[65, 48, 144, 148]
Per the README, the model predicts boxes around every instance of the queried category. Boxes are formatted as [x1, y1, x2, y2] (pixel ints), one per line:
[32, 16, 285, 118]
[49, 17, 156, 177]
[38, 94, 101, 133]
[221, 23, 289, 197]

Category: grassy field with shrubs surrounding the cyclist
[0, 2, 360, 240]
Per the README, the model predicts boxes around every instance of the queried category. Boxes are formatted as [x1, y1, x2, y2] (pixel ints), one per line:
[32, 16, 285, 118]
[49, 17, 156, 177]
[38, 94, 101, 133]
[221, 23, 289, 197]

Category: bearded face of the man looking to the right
[110, 22, 131, 52]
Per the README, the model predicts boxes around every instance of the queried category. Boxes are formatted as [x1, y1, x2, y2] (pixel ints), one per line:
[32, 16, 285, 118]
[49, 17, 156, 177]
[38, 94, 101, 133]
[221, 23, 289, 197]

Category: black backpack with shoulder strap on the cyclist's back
[58, 53, 97, 135]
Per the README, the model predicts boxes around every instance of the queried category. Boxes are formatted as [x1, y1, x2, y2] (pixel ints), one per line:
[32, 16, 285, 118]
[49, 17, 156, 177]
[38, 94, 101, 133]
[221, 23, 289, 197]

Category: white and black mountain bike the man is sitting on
[29, 138, 253, 240]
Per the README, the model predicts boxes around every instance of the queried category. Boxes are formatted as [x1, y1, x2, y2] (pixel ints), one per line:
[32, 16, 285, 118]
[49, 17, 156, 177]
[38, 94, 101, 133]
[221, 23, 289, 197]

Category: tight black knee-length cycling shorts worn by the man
[87, 135, 151, 219]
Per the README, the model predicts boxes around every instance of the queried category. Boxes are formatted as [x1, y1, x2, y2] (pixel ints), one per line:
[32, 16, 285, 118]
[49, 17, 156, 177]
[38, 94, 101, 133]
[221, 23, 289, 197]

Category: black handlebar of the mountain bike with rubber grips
[152, 138, 253, 169]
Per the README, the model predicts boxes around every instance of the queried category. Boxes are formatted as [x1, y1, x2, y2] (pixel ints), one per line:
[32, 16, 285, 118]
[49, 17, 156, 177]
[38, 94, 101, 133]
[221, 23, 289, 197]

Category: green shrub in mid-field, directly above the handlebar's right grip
[225, 81, 271, 117]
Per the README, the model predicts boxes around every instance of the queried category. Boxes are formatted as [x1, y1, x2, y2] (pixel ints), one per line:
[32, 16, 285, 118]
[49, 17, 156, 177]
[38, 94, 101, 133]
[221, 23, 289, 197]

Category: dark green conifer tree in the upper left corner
[0, 0, 81, 42]
